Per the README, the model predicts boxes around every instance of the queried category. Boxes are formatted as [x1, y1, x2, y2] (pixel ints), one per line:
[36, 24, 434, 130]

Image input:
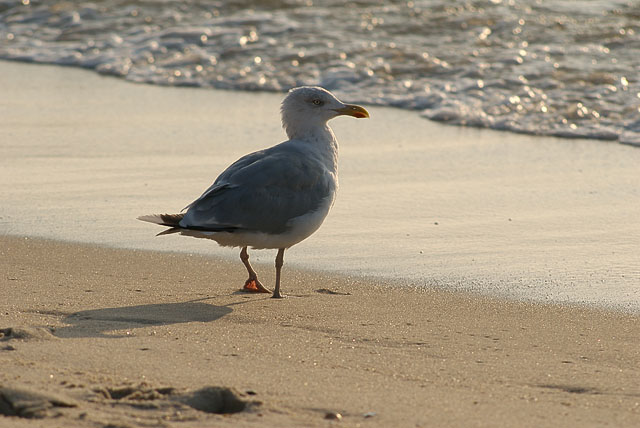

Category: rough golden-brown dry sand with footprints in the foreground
[0, 237, 640, 428]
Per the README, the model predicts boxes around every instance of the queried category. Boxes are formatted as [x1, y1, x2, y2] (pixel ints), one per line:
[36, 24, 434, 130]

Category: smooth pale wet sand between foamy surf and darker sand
[0, 62, 640, 313]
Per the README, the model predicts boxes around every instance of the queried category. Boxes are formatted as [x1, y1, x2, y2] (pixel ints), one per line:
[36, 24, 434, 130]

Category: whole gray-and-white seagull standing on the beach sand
[138, 86, 369, 298]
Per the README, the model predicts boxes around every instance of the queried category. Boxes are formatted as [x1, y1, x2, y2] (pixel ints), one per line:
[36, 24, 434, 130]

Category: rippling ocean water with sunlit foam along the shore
[0, 0, 640, 145]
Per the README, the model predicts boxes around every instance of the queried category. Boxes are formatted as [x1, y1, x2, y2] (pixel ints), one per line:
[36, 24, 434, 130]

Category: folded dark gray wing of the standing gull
[180, 143, 335, 233]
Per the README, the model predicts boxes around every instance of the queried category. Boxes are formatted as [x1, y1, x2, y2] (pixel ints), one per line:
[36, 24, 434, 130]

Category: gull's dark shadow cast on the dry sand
[54, 299, 233, 338]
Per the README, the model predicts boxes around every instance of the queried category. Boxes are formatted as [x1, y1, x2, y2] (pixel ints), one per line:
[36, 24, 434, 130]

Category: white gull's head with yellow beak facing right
[281, 86, 369, 138]
